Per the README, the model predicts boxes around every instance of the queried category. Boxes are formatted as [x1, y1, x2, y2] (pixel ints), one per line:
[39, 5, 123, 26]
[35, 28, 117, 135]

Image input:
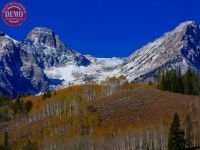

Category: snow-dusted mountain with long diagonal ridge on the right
[122, 21, 200, 82]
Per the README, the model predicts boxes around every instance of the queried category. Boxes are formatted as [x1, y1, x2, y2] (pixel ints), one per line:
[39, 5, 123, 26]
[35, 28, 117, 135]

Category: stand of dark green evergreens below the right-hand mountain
[157, 68, 200, 95]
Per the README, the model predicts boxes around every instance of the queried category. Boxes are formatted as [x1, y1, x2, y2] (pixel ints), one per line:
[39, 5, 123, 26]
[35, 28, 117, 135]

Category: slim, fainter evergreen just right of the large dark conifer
[184, 115, 192, 146]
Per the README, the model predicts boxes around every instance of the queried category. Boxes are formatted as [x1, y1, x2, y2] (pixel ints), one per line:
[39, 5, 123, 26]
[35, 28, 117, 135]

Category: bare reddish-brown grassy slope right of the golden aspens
[91, 87, 200, 127]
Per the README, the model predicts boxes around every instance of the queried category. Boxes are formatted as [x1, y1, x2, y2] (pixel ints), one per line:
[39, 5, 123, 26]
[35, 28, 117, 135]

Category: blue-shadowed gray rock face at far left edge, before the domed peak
[0, 36, 47, 97]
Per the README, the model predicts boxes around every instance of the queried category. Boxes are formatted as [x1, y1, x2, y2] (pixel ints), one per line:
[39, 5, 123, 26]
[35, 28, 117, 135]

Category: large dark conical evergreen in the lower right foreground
[168, 113, 185, 150]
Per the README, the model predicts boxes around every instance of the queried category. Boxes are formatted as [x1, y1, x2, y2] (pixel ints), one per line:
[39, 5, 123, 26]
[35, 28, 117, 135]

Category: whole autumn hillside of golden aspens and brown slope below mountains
[0, 77, 200, 149]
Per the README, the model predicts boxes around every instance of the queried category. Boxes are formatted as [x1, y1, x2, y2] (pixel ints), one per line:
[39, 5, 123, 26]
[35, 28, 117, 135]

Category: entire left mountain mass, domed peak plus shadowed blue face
[0, 27, 91, 97]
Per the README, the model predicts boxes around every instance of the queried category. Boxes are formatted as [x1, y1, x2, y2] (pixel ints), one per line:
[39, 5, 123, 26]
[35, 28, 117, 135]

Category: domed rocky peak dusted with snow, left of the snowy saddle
[21, 28, 90, 69]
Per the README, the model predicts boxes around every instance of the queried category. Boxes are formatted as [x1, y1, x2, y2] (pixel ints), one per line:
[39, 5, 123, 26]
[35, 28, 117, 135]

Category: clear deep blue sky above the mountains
[0, 0, 200, 57]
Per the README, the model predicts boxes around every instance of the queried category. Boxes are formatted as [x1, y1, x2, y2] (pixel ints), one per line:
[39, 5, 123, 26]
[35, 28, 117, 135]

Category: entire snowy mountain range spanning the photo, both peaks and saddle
[0, 21, 200, 97]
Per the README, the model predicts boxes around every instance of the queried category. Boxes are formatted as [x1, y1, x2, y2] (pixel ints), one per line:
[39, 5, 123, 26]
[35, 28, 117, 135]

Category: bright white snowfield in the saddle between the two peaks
[44, 56, 125, 87]
